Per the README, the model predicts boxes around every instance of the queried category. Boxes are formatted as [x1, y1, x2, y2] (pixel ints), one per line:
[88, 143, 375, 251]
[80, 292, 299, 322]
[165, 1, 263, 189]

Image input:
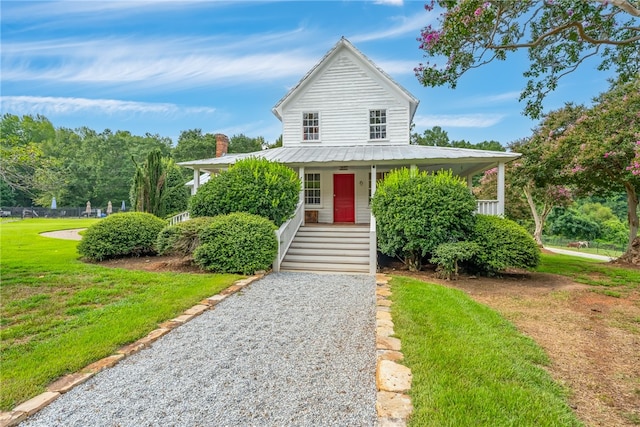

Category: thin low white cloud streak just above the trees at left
[0, 96, 216, 116]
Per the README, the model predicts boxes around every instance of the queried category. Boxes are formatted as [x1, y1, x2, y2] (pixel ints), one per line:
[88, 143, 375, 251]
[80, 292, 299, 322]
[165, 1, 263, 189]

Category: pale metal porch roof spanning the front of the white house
[178, 144, 520, 175]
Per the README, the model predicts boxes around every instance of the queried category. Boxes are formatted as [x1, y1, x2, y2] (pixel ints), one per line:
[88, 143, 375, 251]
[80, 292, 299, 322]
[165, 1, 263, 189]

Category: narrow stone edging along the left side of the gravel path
[0, 272, 266, 427]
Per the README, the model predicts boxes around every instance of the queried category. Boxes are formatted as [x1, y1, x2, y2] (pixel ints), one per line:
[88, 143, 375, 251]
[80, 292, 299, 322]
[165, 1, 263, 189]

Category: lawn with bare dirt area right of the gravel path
[392, 254, 640, 427]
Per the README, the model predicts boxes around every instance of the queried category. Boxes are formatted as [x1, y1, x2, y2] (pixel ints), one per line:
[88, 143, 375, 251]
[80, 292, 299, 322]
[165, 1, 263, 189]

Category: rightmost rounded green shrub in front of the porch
[470, 215, 540, 275]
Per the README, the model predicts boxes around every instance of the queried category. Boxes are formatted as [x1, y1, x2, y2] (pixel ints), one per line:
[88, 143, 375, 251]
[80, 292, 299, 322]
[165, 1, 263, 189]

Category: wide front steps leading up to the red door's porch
[280, 224, 369, 273]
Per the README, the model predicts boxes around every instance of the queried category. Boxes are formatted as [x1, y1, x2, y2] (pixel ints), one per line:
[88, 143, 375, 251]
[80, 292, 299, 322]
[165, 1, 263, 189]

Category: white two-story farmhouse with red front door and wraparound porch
[180, 38, 519, 273]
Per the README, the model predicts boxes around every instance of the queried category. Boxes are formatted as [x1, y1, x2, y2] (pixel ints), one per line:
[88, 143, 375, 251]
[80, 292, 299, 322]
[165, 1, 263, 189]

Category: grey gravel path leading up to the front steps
[21, 273, 376, 427]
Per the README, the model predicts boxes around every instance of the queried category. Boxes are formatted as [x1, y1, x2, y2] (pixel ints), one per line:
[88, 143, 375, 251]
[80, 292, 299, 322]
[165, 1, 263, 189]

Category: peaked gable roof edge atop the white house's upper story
[271, 37, 420, 120]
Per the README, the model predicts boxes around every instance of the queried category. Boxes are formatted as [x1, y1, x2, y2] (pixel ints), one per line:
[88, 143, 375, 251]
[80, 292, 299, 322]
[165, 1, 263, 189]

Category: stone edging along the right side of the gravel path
[376, 274, 413, 427]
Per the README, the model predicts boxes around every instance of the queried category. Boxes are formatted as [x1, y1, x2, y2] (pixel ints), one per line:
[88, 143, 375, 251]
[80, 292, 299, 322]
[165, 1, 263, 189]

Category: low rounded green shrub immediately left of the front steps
[193, 212, 278, 274]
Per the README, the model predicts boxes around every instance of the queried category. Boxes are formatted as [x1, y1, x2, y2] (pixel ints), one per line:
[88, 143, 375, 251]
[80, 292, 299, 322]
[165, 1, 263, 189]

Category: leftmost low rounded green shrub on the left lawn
[78, 212, 167, 261]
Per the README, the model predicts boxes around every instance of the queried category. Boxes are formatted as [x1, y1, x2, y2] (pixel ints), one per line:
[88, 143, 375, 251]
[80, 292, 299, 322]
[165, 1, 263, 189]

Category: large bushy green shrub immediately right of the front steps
[371, 168, 476, 270]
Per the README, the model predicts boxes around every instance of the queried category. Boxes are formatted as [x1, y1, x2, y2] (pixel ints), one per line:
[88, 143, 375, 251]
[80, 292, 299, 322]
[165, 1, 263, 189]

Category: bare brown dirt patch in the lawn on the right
[387, 270, 640, 426]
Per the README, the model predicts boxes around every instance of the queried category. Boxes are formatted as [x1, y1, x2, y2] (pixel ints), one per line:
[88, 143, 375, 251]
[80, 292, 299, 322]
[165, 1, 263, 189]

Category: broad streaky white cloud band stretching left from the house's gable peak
[2, 34, 317, 88]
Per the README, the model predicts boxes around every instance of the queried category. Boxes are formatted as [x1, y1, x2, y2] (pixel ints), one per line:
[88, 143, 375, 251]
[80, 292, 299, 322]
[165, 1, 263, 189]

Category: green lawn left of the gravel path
[0, 219, 240, 410]
